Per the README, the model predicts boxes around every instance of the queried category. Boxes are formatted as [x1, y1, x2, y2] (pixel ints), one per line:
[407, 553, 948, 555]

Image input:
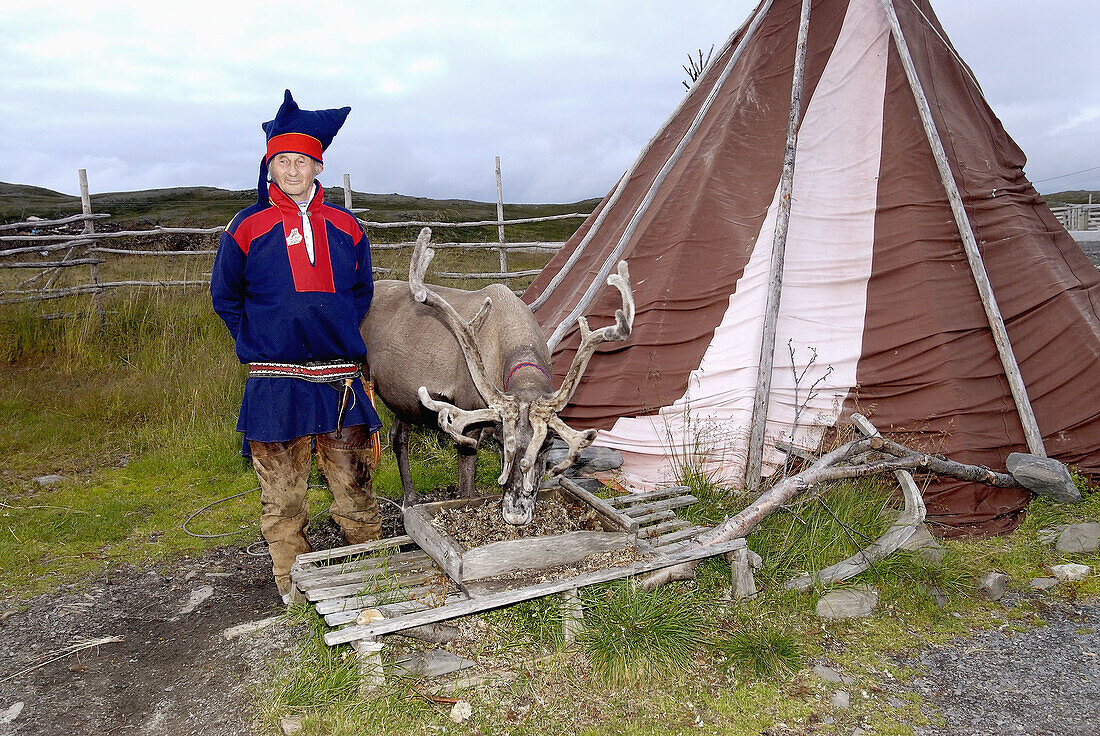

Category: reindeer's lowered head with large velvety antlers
[409, 228, 634, 525]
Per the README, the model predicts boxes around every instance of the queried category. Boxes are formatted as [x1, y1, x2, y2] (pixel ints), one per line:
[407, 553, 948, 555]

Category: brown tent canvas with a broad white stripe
[524, 0, 1100, 534]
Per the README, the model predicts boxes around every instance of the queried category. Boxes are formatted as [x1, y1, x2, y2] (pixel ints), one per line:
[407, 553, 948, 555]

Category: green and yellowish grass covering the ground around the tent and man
[0, 182, 1100, 736]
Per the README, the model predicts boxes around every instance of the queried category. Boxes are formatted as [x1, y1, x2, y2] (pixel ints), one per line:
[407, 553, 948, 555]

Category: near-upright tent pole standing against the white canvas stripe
[745, 0, 811, 490]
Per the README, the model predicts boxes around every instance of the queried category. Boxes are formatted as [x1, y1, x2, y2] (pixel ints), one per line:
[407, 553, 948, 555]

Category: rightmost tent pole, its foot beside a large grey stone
[881, 0, 1046, 458]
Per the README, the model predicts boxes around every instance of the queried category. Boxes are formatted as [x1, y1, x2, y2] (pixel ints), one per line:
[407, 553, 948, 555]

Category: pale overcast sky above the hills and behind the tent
[0, 0, 1100, 202]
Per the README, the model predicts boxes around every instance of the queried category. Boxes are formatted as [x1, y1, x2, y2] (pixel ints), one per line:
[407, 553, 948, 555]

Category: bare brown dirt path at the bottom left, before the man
[0, 548, 289, 736]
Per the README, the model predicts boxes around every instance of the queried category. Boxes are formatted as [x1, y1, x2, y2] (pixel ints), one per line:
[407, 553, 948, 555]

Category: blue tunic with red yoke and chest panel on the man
[210, 184, 382, 448]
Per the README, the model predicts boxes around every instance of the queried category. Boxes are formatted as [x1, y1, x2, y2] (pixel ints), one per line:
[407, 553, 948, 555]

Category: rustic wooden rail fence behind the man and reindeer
[0, 163, 587, 305]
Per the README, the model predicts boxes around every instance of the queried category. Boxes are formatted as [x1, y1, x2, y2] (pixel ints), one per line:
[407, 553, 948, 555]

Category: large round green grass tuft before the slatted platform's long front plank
[580, 582, 702, 683]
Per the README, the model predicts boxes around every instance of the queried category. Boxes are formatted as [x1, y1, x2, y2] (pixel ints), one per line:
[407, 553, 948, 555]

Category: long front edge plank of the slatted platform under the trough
[325, 539, 745, 646]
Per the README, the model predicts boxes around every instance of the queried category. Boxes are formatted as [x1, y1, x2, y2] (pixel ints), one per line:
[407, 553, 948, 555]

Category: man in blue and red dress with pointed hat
[210, 90, 382, 602]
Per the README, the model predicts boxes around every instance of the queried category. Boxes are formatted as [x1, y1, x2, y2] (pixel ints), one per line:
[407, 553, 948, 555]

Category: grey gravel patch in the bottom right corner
[902, 604, 1100, 736]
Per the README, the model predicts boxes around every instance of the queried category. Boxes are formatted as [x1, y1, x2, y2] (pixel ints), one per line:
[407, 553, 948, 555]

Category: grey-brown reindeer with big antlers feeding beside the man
[360, 228, 634, 525]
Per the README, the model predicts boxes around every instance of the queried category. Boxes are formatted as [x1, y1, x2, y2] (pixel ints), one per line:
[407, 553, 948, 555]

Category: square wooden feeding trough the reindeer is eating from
[405, 484, 638, 584]
